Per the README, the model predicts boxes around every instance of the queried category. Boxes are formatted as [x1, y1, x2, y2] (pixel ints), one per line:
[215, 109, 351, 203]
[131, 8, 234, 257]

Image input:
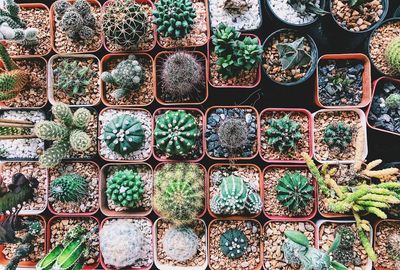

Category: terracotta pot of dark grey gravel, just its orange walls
[314, 53, 371, 109]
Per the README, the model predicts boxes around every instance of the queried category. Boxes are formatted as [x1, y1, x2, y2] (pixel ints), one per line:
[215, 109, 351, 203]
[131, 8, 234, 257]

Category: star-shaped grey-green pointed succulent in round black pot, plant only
[276, 37, 311, 70]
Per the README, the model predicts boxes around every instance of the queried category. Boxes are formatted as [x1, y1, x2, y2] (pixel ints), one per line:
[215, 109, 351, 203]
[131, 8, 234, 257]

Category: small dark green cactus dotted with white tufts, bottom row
[219, 229, 248, 259]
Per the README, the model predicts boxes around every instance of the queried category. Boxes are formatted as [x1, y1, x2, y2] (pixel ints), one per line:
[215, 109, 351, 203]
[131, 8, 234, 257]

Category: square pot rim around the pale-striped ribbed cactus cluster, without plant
[207, 163, 264, 220]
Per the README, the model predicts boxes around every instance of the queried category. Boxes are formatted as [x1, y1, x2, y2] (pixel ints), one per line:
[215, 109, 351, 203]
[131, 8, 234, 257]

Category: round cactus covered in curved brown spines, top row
[103, 0, 148, 49]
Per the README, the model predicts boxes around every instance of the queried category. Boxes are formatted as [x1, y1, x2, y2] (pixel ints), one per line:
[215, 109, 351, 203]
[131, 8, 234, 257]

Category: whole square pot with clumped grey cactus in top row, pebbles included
[50, 0, 102, 53]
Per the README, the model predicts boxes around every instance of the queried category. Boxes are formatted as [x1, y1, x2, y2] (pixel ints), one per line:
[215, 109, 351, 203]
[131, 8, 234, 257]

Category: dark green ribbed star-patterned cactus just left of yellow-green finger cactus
[276, 173, 314, 214]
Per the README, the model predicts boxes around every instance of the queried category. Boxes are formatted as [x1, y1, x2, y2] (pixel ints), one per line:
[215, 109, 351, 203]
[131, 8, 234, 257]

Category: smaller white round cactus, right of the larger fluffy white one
[162, 226, 200, 262]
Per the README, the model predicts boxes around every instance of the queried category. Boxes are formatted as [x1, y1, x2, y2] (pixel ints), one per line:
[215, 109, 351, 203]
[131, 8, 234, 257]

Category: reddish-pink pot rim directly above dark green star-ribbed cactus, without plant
[258, 108, 314, 164]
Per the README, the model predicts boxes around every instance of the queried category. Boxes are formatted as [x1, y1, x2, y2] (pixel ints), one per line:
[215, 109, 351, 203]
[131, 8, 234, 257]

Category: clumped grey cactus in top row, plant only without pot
[54, 0, 96, 41]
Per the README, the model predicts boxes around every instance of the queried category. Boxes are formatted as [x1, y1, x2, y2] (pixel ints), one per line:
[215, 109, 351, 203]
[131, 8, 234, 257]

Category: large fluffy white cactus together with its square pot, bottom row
[100, 218, 153, 270]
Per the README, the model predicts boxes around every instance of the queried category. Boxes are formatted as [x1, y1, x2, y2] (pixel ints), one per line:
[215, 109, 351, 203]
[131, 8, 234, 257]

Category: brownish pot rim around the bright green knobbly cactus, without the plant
[99, 163, 154, 217]
